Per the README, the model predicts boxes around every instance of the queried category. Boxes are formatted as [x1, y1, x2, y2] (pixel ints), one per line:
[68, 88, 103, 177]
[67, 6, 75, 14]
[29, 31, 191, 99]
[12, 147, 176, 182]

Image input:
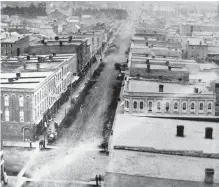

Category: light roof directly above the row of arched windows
[124, 79, 213, 95]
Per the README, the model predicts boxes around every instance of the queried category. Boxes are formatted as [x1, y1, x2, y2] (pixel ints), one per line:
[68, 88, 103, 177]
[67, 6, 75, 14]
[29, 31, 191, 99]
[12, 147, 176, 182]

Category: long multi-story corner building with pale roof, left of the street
[1, 54, 77, 141]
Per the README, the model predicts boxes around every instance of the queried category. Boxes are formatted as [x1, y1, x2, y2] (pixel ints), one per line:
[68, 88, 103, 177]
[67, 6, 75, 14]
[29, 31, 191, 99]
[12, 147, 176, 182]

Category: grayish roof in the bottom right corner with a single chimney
[104, 150, 219, 187]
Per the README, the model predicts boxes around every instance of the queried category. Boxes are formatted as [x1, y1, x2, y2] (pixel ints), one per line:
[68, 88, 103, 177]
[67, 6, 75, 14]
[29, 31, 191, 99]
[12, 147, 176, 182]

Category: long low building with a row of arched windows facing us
[123, 79, 216, 116]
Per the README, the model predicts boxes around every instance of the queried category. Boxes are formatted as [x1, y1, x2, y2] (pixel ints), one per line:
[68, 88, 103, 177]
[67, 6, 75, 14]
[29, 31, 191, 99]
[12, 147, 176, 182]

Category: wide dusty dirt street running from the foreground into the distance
[23, 13, 133, 186]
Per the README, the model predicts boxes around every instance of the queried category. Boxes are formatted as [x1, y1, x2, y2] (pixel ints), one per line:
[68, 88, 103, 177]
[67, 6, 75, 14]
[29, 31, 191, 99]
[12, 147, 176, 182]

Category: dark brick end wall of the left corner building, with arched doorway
[1, 89, 33, 140]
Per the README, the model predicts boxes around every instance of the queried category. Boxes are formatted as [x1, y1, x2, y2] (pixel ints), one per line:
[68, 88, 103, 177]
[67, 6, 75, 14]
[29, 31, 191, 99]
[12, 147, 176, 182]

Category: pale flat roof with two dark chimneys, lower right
[112, 114, 219, 154]
